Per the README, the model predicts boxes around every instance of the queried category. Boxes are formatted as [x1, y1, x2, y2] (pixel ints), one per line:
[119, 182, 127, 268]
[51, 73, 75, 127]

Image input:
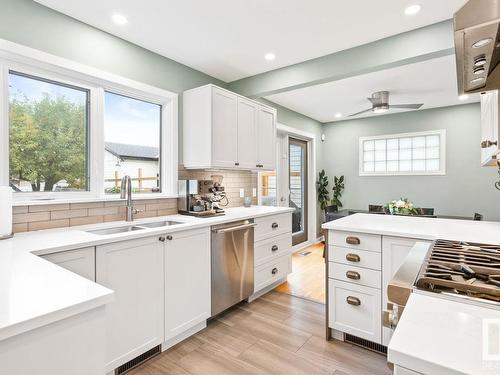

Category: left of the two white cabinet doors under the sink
[96, 236, 164, 372]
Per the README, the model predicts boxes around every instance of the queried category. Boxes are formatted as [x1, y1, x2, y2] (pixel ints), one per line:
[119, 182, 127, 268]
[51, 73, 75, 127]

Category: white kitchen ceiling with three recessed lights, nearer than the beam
[36, 0, 465, 82]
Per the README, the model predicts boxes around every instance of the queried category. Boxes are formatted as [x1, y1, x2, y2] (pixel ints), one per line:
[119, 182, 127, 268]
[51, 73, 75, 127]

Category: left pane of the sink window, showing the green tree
[9, 72, 89, 193]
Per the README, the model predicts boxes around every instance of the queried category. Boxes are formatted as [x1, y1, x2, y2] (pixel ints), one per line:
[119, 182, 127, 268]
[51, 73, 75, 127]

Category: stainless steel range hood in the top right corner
[453, 0, 500, 94]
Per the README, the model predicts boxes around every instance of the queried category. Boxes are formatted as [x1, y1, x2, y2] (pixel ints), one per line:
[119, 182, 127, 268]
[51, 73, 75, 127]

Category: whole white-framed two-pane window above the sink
[0, 43, 178, 204]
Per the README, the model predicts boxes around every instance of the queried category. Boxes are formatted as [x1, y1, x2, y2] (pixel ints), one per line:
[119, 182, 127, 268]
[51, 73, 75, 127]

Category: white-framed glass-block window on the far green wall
[359, 130, 446, 176]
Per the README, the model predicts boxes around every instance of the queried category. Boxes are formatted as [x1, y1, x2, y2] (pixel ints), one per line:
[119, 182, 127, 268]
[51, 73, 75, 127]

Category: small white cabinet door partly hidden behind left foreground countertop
[41, 247, 95, 281]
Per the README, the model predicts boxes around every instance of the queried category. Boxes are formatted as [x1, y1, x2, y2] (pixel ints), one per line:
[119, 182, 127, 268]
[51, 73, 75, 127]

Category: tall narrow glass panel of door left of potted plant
[288, 138, 307, 245]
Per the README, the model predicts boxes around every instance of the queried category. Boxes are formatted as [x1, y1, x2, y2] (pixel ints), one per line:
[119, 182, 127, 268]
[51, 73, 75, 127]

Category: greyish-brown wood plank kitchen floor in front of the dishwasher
[129, 291, 392, 375]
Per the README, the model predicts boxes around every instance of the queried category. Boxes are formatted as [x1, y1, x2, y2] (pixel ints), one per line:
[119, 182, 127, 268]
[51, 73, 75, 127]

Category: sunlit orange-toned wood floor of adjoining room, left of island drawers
[275, 242, 325, 303]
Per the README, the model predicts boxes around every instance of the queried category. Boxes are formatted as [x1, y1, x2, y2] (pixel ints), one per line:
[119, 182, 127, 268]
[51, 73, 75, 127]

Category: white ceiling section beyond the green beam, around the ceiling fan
[266, 55, 479, 122]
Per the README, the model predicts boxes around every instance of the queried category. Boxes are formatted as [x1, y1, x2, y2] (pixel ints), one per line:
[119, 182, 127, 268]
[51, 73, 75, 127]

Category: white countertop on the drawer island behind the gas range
[322, 214, 500, 244]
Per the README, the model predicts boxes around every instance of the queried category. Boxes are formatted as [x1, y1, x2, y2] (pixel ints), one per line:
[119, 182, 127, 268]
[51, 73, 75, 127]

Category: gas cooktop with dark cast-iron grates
[414, 239, 500, 310]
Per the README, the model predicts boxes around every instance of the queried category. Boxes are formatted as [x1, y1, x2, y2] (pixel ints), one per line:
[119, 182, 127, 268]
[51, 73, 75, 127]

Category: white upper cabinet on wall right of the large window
[183, 85, 276, 170]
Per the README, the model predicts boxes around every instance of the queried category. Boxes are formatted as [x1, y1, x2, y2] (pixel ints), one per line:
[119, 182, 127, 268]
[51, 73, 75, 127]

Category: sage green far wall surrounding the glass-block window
[322, 104, 500, 221]
